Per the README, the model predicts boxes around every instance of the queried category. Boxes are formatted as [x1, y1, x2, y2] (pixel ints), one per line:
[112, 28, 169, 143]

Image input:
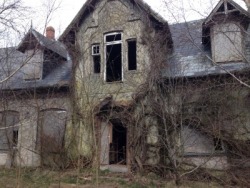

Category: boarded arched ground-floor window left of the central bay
[37, 109, 66, 154]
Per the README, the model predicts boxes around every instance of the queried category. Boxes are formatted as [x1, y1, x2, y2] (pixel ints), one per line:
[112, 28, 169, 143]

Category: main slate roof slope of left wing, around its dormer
[0, 48, 72, 90]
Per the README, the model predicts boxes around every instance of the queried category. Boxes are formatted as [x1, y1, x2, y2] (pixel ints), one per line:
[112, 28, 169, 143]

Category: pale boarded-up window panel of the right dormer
[211, 23, 243, 63]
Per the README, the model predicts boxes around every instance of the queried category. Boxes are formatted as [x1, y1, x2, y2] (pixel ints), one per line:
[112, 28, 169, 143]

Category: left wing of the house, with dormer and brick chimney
[0, 27, 71, 166]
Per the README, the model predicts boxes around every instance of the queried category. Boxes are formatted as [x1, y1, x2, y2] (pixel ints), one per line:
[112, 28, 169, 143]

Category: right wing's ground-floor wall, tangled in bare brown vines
[164, 75, 250, 169]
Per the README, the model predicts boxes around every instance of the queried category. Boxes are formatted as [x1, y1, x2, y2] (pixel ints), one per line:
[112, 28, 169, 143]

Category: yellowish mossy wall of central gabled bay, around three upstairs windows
[75, 0, 167, 159]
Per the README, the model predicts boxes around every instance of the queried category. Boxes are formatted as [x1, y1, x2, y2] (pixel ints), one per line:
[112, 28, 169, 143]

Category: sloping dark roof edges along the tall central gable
[59, 0, 170, 40]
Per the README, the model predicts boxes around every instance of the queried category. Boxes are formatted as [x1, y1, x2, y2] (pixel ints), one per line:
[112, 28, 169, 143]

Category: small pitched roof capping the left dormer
[17, 28, 68, 59]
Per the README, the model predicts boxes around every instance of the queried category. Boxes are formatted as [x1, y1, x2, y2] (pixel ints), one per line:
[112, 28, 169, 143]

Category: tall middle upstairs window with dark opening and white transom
[104, 33, 122, 82]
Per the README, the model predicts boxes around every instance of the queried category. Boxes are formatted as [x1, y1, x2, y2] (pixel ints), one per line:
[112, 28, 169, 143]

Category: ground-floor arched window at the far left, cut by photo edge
[0, 111, 19, 151]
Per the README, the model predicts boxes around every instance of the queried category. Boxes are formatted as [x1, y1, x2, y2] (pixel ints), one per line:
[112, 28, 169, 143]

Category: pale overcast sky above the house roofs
[0, 0, 246, 45]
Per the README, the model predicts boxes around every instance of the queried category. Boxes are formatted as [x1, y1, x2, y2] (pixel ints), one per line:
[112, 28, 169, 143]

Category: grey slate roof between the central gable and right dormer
[163, 20, 250, 78]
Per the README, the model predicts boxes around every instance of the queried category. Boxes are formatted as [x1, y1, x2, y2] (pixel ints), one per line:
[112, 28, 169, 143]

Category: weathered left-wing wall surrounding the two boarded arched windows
[0, 95, 71, 167]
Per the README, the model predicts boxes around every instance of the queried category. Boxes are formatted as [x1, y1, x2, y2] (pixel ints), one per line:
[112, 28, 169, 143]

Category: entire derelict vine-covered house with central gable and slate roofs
[0, 0, 250, 172]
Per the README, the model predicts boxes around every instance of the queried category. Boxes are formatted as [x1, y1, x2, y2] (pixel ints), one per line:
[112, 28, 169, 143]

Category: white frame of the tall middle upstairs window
[104, 32, 124, 83]
